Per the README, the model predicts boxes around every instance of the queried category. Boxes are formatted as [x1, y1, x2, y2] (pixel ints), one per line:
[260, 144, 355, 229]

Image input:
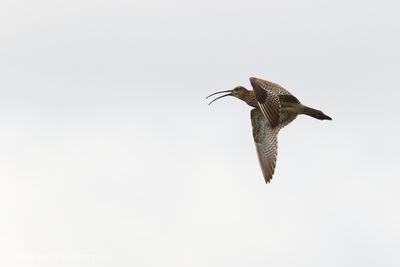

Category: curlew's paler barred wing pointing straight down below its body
[251, 108, 279, 183]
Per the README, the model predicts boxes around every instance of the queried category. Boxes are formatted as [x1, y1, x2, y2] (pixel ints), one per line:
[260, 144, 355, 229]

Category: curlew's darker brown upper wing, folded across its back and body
[250, 77, 291, 128]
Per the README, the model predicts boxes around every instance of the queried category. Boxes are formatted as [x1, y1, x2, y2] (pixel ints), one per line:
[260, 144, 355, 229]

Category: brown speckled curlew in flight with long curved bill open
[206, 77, 332, 184]
